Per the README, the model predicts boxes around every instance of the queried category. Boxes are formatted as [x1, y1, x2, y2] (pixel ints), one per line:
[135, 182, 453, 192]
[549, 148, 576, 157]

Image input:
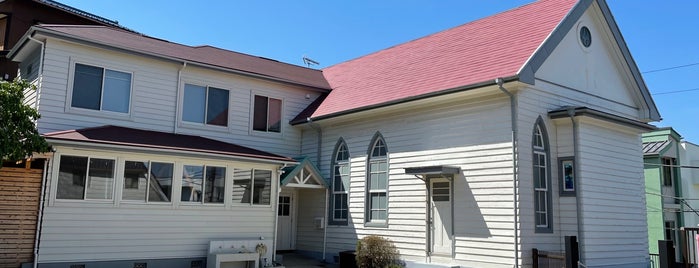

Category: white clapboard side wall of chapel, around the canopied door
[303, 90, 514, 267]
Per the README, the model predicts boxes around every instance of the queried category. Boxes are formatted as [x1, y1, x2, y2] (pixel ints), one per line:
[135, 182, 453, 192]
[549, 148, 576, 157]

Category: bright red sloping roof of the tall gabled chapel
[311, 0, 577, 117]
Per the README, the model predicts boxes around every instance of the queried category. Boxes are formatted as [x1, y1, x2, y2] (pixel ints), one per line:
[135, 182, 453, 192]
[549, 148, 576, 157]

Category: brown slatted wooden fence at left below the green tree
[0, 167, 42, 268]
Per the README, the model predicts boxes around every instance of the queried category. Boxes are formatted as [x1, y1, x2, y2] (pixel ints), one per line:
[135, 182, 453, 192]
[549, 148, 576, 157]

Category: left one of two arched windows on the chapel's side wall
[328, 138, 350, 225]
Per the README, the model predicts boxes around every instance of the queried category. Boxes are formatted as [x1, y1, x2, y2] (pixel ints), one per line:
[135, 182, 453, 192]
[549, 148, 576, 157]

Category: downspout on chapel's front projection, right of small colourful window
[568, 107, 585, 267]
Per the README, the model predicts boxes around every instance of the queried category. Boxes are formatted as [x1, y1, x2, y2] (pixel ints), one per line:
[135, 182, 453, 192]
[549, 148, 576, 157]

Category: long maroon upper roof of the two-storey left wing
[36, 25, 330, 91]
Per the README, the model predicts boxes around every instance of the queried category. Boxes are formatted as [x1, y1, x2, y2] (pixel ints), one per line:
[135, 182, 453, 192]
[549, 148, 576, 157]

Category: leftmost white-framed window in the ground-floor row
[56, 155, 115, 200]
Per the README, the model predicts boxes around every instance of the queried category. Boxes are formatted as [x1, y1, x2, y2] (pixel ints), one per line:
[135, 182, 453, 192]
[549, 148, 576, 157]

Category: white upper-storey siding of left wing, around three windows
[29, 38, 319, 156]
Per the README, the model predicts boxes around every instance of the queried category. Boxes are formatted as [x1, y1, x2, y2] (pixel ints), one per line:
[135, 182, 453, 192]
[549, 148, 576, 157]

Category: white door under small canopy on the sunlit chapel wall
[430, 179, 452, 256]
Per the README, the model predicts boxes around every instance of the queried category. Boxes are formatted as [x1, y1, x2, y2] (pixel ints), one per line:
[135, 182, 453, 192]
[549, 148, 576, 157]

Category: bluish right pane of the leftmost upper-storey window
[102, 70, 131, 113]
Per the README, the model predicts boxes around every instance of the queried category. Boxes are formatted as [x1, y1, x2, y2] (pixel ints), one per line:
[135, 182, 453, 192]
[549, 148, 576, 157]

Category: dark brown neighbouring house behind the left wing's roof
[0, 0, 123, 80]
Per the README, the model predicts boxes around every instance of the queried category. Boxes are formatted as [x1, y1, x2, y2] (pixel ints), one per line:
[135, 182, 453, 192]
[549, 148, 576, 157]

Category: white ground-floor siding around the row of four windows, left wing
[39, 147, 279, 263]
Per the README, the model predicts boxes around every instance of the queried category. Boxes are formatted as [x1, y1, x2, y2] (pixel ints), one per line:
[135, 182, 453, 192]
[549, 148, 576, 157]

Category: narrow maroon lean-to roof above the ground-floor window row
[44, 126, 296, 162]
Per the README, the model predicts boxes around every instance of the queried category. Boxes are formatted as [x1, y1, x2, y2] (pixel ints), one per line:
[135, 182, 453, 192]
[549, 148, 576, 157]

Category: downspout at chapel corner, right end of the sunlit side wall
[495, 78, 519, 268]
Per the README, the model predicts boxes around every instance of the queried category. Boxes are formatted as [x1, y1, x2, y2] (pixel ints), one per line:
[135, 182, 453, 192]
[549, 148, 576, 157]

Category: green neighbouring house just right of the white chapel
[643, 128, 686, 256]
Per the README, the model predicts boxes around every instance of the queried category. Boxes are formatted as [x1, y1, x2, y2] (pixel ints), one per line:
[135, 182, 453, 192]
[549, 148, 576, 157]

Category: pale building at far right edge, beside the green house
[679, 141, 699, 227]
